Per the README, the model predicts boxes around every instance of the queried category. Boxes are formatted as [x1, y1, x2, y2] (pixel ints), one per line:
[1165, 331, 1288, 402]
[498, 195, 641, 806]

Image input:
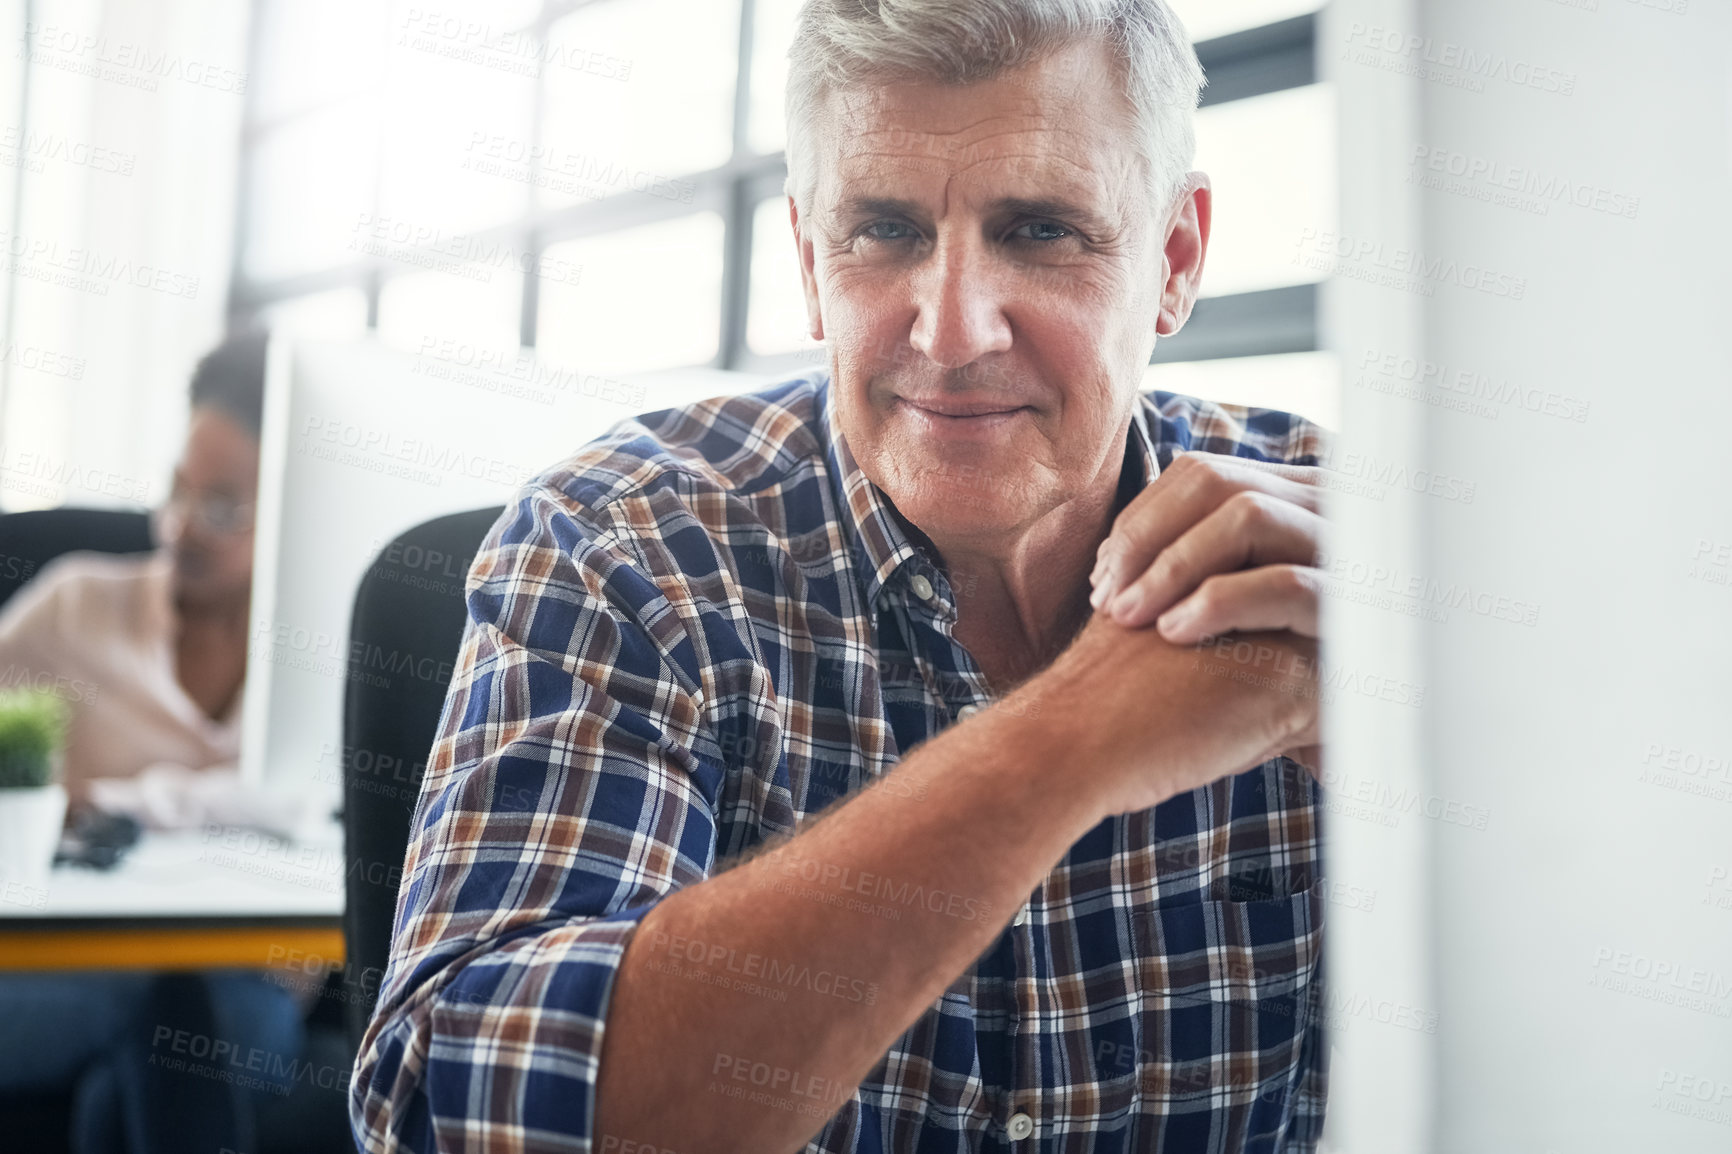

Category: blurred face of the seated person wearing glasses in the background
[163, 405, 258, 605]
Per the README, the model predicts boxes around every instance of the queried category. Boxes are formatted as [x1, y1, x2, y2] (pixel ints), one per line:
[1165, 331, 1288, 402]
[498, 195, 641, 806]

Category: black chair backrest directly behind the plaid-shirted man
[343, 508, 504, 1047]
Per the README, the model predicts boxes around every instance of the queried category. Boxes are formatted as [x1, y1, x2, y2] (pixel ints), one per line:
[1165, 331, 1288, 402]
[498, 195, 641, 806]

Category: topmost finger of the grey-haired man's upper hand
[1089, 452, 1322, 608]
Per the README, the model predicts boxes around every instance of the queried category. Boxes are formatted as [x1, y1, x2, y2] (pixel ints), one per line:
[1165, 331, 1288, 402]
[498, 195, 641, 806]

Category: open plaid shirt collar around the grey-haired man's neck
[818, 369, 1160, 617]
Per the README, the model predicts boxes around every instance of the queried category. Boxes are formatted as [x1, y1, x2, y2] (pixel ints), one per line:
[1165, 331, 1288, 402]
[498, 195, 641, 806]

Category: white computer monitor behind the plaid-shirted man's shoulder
[241, 332, 767, 802]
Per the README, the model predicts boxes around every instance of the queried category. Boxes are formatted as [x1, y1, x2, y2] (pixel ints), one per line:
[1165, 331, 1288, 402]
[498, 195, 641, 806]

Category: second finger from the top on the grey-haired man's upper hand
[1103, 489, 1327, 627]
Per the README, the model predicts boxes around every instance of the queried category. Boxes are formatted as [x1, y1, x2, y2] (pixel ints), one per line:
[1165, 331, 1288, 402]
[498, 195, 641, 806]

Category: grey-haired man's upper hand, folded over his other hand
[1089, 452, 1327, 773]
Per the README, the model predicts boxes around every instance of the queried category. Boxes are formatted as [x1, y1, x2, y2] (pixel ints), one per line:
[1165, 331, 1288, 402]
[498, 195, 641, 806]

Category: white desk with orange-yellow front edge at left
[0, 821, 343, 970]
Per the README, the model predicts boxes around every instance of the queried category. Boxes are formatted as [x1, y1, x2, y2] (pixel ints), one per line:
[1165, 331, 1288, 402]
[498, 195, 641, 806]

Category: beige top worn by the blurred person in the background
[0, 549, 242, 795]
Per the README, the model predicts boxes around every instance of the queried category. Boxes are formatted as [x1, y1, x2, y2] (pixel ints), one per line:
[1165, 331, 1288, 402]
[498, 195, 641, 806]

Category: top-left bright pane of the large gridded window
[255, 0, 386, 123]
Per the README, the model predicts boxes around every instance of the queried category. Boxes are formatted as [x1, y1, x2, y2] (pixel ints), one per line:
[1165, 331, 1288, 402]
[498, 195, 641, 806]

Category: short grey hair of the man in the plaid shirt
[785, 0, 1204, 215]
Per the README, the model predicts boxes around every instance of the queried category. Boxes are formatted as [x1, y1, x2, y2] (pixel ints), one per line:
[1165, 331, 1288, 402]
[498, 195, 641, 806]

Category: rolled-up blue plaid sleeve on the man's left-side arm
[350, 475, 721, 1151]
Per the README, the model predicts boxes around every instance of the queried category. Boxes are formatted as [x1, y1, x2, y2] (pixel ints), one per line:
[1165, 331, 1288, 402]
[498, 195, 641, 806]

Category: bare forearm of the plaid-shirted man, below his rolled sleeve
[594, 696, 1103, 1154]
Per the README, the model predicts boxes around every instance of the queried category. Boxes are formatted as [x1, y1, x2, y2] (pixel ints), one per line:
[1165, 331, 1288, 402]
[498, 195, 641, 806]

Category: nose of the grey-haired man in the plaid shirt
[909, 236, 1010, 369]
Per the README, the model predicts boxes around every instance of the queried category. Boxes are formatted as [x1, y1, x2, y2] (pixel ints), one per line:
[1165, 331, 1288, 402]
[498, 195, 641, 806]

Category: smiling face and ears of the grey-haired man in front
[790, 43, 1209, 549]
